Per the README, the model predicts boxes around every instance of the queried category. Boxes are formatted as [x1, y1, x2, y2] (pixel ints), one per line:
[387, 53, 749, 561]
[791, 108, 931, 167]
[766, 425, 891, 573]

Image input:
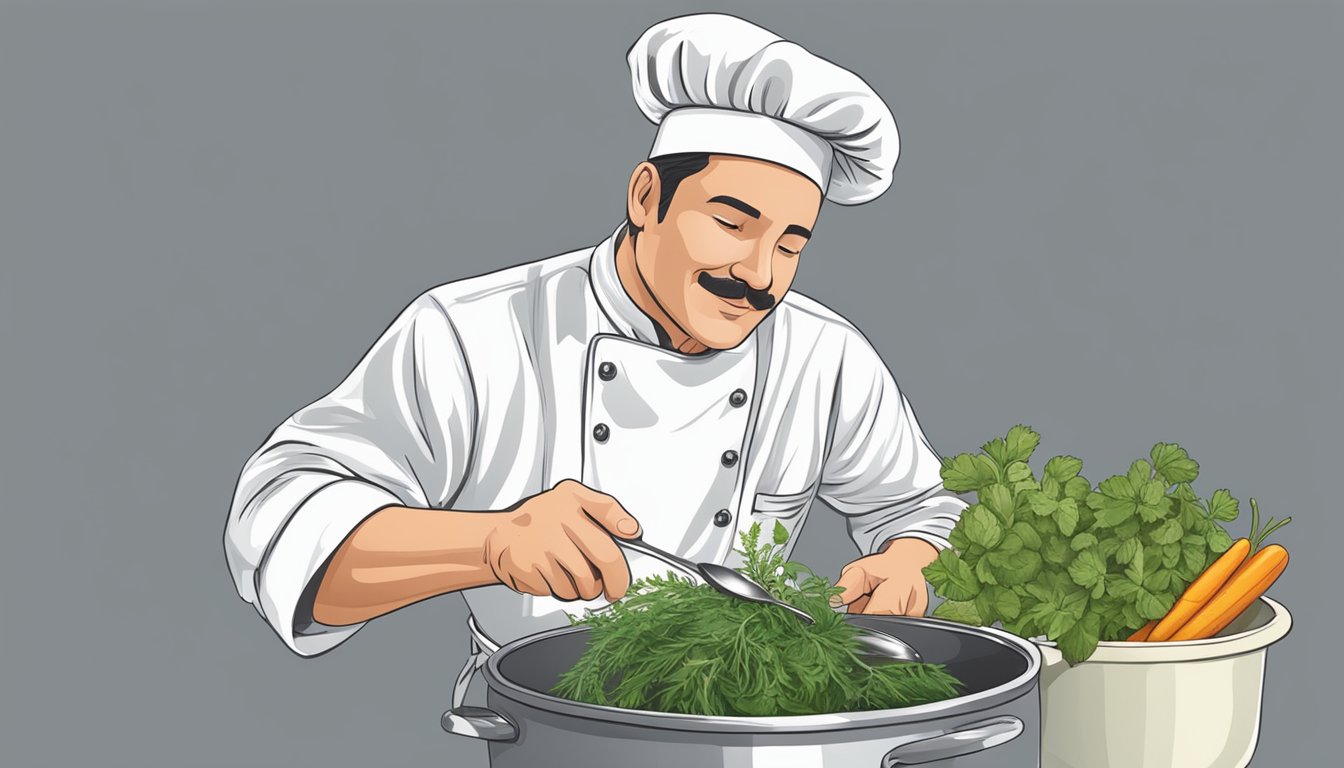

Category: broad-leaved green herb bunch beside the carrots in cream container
[925, 425, 1238, 664]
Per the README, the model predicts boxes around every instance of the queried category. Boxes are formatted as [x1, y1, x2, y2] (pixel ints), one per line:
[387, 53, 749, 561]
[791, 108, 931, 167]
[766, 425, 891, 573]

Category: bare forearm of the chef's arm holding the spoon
[313, 507, 497, 627]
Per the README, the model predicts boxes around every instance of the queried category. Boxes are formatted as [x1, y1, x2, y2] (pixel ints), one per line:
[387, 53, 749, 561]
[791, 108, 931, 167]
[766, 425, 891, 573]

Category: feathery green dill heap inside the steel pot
[551, 523, 960, 717]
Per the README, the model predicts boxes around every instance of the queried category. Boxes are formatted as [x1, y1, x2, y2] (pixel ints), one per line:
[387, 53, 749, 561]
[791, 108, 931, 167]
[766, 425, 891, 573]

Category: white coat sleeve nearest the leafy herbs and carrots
[817, 328, 966, 554]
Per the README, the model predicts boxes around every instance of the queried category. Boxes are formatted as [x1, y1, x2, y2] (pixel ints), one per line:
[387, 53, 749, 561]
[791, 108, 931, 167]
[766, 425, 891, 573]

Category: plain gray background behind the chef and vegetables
[0, 1, 1344, 767]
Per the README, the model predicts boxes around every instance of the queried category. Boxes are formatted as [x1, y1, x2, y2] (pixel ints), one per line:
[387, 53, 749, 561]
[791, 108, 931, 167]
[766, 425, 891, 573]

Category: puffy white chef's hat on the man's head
[628, 13, 900, 206]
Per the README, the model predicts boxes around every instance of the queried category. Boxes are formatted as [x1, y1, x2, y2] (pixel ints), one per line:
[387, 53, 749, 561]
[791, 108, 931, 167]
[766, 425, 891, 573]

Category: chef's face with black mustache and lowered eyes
[628, 155, 823, 350]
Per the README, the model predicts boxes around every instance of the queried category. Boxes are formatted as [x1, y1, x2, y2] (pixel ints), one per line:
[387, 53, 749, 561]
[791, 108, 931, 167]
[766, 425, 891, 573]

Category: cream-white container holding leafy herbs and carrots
[1036, 597, 1293, 768]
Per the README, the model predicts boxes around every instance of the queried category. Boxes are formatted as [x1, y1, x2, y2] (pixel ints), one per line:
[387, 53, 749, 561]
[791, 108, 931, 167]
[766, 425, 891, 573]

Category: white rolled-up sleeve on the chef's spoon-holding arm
[224, 293, 474, 656]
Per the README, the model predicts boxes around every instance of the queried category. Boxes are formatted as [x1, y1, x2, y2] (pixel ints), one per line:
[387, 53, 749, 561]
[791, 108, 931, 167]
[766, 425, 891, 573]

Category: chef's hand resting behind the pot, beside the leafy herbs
[835, 538, 938, 616]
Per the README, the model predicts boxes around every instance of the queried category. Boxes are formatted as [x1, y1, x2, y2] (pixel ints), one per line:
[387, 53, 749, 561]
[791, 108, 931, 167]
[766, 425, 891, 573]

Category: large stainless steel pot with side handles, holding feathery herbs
[444, 616, 1040, 768]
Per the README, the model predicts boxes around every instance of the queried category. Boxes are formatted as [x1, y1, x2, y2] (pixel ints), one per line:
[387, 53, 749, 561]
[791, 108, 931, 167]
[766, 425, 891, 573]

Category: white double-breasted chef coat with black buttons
[224, 225, 965, 656]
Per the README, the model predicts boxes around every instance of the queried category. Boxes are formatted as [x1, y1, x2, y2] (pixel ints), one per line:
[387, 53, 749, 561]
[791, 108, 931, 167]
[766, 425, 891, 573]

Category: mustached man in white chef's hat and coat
[224, 13, 965, 703]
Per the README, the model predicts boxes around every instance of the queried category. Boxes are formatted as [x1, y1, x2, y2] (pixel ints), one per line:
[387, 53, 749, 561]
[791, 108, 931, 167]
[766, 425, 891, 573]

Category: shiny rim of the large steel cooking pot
[484, 615, 1042, 733]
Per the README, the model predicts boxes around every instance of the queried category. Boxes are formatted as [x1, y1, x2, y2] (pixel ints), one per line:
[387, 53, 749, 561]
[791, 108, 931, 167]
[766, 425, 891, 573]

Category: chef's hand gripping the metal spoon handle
[482, 480, 640, 601]
